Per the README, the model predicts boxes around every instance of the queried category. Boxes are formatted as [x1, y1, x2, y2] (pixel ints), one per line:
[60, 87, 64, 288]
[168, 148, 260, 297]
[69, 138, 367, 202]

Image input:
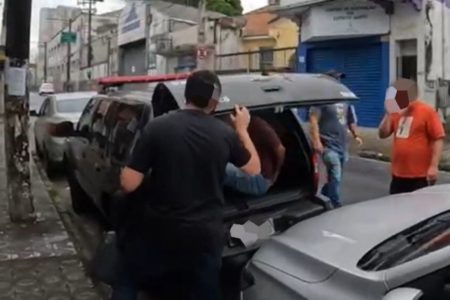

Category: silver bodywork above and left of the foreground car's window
[253, 185, 450, 283]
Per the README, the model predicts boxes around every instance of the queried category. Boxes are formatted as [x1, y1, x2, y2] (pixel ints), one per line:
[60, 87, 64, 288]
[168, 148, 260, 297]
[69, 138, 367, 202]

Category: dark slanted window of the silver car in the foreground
[358, 211, 450, 271]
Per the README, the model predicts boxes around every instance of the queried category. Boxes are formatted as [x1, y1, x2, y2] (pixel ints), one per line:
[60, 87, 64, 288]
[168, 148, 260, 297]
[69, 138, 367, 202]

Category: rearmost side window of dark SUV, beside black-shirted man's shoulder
[110, 101, 145, 161]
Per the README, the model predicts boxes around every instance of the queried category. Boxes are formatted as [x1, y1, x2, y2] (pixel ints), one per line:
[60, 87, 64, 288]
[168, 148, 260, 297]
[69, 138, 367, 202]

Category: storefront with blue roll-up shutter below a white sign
[298, 0, 390, 127]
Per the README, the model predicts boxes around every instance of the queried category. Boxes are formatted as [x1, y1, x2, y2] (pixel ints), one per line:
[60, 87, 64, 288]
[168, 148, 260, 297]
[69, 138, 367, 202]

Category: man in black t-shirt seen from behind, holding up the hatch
[113, 71, 261, 300]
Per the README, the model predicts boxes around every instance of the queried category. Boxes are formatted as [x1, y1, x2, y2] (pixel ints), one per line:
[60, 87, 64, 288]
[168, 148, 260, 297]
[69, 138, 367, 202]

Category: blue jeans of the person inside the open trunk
[224, 163, 272, 196]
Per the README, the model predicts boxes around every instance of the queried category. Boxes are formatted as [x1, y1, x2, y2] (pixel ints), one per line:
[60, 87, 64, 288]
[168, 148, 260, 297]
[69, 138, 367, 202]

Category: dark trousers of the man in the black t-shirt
[111, 239, 222, 300]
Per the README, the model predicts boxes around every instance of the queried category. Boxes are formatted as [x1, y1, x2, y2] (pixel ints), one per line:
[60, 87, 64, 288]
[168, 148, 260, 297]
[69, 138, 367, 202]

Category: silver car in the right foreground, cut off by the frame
[244, 185, 450, 300]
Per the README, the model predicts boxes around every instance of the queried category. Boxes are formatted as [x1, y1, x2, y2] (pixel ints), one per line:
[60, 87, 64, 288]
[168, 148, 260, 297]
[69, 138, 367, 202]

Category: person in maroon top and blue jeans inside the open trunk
[224, 117, 286, 196]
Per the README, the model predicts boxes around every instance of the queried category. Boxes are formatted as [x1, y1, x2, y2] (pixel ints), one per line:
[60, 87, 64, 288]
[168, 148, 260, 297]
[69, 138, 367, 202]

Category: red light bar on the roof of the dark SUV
[98, 73, 190, 87]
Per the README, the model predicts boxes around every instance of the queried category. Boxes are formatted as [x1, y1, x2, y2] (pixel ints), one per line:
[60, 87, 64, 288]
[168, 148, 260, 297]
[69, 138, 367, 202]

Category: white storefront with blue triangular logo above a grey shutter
[118, 1, 147, 75]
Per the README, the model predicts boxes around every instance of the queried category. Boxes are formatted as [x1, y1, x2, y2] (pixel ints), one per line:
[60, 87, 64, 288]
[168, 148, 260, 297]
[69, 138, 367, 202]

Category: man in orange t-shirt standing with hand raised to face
[379, 79, 445, 194]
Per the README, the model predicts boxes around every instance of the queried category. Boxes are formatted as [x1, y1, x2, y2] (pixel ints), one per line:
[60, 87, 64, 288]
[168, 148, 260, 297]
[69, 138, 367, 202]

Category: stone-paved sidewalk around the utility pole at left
[0, 121, 101, 300]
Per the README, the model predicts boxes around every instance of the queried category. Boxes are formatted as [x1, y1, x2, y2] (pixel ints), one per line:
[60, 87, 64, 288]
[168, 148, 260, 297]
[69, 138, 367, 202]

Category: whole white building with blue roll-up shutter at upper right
[280, 0, 450, 127]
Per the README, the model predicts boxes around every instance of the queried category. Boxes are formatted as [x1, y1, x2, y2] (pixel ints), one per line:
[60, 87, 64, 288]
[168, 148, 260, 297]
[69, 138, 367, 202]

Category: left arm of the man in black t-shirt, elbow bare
[120, 125, 154, 193]
